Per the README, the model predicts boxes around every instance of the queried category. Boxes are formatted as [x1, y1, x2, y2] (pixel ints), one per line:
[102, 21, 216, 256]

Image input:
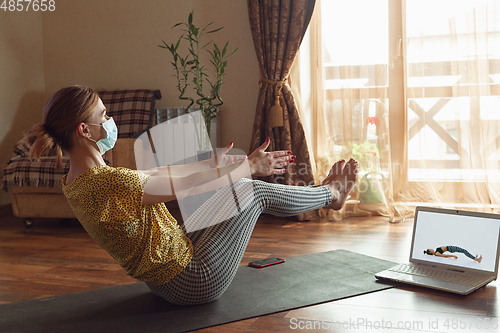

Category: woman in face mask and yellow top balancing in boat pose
[25, 86, 358, 305]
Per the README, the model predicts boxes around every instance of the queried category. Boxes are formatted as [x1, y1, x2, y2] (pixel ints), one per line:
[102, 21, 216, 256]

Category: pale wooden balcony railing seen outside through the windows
[325, 59, 500, 181]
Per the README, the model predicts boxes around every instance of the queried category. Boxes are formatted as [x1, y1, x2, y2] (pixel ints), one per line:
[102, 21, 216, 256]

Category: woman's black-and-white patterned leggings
[148, 178, 332, 305]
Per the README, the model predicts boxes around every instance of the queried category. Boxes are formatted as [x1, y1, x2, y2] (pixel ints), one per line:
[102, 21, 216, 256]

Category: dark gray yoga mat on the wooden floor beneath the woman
[0, 250, 394, 333]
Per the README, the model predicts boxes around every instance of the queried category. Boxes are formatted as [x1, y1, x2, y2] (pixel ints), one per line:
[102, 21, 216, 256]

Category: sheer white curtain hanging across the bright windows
[291, 0, 500, 221]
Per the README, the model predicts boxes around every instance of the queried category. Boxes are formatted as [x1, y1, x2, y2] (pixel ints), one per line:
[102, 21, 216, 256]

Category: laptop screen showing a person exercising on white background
[411, 210, 500, 273]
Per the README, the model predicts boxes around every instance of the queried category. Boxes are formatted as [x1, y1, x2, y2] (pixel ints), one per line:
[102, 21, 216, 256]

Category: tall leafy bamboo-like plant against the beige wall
[158, 11, 237, 147]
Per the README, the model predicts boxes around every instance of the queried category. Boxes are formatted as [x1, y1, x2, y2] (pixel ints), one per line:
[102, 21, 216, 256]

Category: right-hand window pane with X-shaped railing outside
[405, 0, 500, 181]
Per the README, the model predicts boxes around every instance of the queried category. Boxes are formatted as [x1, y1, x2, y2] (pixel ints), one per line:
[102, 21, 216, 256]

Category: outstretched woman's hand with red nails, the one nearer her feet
[248, 138, 295, 177]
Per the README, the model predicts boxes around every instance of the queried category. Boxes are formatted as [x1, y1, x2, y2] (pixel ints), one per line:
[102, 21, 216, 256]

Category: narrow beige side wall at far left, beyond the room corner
[0, 10, 45, 205]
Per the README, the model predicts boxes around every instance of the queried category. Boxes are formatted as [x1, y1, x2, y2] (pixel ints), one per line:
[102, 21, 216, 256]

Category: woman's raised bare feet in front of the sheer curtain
[322, 158, 359, 210]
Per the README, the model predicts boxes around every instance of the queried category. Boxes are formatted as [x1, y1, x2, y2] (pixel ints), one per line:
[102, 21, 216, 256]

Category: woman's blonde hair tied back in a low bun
[22, 86, 99, 170]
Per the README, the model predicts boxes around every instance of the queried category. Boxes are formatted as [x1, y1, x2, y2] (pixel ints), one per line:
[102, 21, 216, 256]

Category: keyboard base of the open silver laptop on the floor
[389, 264, 484, 287]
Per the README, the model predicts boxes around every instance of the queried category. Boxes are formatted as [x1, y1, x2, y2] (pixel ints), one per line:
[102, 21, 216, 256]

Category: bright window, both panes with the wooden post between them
[320, 0, 500, 182]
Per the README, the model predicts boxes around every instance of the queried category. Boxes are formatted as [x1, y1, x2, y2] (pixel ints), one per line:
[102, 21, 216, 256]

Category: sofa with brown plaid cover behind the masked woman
[2, 89, 161, 226]
